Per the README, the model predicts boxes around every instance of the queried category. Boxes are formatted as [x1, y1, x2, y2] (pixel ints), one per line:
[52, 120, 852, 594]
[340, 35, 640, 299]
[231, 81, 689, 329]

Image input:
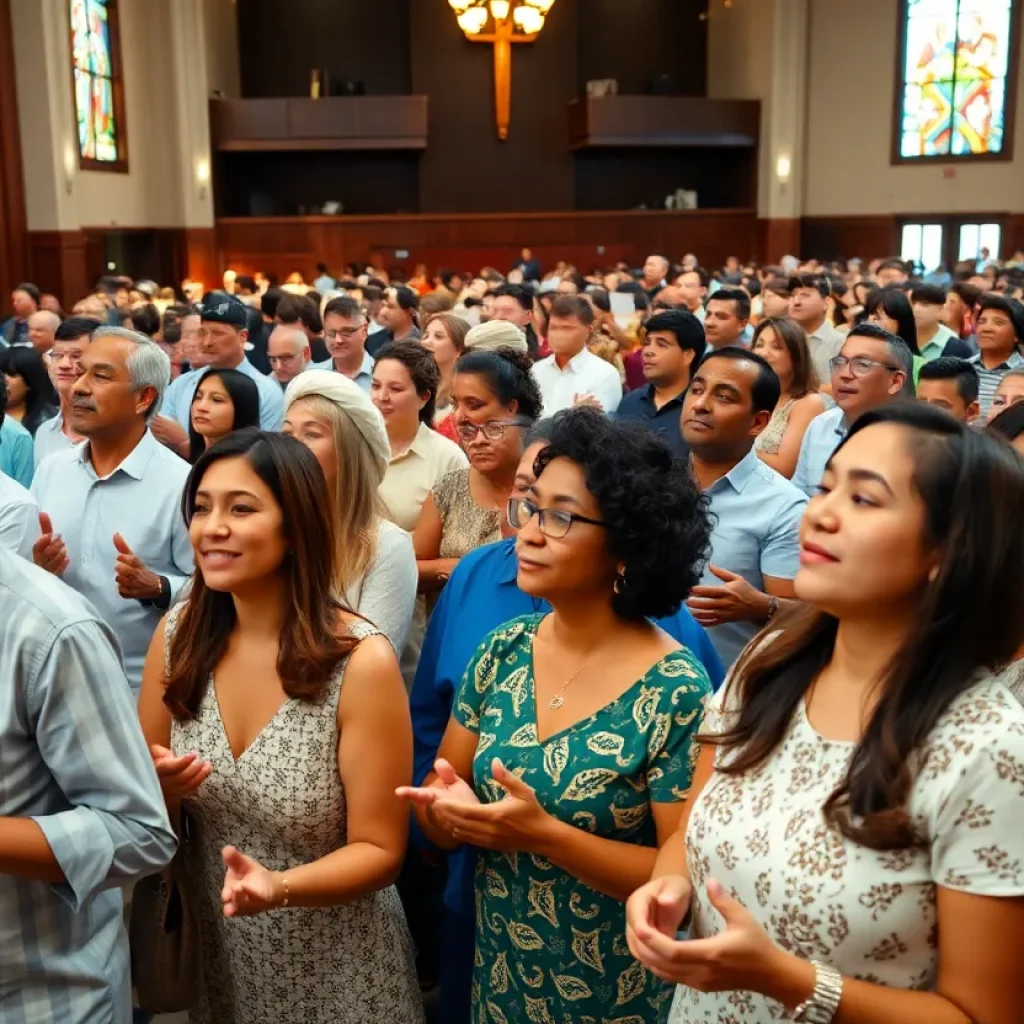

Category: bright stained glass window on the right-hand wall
[897, 0, 1013, 160]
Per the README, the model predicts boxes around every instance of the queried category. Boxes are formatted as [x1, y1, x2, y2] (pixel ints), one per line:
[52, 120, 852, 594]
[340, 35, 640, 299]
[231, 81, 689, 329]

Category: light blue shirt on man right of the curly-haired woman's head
[700, 450, 807, 668]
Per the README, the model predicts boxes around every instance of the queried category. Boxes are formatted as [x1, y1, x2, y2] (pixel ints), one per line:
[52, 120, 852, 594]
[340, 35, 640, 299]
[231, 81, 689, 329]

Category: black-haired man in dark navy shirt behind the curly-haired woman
[615, 309, 707, 458]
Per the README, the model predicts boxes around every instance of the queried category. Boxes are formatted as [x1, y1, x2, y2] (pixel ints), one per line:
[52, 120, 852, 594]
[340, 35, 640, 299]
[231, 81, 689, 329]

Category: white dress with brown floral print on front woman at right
[672, 678, 1024, 1024]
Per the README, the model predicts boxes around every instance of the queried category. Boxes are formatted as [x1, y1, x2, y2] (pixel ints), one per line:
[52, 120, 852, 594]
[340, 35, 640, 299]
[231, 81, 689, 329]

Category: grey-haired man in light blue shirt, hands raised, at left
[32, 328, 193, 694]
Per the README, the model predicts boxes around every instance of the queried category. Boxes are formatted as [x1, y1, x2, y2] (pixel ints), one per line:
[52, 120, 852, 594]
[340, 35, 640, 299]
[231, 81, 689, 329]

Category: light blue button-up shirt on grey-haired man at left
[32, 430, 194, 692]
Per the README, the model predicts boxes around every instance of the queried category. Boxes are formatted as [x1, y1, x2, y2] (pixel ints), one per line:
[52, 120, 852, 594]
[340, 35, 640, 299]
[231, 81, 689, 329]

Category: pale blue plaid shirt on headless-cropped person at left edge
[0, 550, 175, 1024]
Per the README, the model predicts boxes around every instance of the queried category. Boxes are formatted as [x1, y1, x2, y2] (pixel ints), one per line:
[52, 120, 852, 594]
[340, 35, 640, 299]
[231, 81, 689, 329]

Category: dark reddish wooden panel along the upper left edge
[0, 0, 29, 299]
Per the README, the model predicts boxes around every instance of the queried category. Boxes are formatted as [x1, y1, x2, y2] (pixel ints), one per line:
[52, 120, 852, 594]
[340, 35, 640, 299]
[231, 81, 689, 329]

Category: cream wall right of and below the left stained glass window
[75, 0, 182, 227]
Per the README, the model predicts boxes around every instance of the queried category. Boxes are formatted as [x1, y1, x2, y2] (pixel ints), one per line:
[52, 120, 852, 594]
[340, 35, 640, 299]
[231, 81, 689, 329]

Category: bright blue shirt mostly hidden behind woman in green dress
[403, 539, 725, 916]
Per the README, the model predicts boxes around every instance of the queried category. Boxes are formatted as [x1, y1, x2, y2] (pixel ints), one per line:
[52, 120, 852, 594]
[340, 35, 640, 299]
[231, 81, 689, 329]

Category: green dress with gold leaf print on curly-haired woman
[454, 614, 711, 1024]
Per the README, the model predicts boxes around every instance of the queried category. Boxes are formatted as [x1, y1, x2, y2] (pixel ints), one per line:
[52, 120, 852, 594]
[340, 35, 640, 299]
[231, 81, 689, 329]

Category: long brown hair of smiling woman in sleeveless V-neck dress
[164, 430, 358, 720]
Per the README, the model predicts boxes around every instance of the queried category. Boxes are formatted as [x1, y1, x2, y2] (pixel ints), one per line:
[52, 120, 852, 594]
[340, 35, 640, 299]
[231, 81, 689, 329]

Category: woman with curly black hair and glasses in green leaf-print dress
[399, 409, 710, 1024]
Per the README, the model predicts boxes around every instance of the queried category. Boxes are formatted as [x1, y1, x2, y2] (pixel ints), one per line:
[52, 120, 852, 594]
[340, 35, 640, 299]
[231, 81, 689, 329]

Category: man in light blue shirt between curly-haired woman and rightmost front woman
[682, 346, 807, 668]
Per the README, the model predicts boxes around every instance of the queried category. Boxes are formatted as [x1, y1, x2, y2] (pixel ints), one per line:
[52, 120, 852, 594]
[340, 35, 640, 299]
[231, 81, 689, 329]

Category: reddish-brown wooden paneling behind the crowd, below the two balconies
[217, 210, 757, 278]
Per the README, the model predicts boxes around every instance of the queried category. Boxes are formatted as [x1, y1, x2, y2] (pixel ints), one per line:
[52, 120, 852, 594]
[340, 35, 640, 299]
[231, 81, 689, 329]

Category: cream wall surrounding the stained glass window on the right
[804, 0, 1024, 216]
